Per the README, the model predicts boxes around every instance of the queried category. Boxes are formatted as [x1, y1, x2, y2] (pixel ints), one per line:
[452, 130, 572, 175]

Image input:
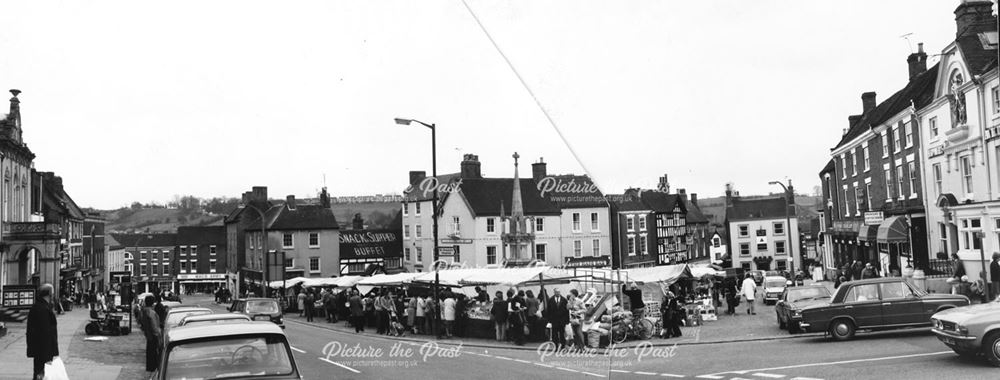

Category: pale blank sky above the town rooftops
[0, 0, 984, 209]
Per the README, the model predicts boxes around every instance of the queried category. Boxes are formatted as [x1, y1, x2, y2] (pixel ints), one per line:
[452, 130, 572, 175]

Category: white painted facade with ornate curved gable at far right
[919, 37, 1000, 277]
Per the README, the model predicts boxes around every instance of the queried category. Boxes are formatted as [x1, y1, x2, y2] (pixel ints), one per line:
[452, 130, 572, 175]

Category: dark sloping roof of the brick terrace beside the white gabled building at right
[833, 64, 938, 150]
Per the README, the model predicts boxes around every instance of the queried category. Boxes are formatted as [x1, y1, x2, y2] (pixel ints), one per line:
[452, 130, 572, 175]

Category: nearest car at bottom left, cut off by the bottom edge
[150, 322, 302, 380]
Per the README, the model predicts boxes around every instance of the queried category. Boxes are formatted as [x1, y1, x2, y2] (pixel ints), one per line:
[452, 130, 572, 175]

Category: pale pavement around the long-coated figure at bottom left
[0, 307, 146, 380]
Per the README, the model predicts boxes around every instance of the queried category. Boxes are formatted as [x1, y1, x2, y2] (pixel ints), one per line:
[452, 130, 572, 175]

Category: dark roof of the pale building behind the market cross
[445, 178, 561, 216]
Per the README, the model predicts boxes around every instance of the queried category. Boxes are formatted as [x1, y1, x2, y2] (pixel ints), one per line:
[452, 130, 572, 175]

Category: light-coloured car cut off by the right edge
[931, 298, 1000, 367]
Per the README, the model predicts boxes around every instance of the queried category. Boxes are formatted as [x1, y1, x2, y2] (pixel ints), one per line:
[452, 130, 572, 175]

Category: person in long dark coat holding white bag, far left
[25, 284, 59, 379]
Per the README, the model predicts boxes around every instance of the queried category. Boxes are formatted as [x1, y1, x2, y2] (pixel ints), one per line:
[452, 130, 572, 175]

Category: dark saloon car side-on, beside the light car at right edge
[799, 277, 969, 340]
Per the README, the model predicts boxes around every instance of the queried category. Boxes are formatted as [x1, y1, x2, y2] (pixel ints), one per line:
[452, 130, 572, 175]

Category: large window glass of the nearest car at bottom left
[163, 336, 294, 380]
